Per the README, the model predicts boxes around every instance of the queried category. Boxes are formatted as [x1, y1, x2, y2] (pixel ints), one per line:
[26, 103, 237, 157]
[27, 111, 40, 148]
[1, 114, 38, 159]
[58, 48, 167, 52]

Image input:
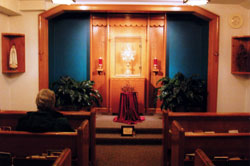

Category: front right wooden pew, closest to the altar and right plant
[162, 111, 250, 166]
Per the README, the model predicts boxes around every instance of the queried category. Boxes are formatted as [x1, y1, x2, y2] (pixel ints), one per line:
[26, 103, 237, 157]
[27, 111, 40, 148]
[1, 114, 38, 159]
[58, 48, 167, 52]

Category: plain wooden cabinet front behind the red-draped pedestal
[110, 78, 145, 113]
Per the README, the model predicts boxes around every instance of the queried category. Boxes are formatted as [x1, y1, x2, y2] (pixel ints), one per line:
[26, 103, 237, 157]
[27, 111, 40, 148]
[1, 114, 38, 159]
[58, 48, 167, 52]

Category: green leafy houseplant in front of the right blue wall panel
[156, 73, 207, 112]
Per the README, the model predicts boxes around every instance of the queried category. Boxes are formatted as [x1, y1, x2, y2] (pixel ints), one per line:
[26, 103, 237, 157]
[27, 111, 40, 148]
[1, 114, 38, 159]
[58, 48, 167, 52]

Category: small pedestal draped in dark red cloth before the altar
[114, 92, 145, 124]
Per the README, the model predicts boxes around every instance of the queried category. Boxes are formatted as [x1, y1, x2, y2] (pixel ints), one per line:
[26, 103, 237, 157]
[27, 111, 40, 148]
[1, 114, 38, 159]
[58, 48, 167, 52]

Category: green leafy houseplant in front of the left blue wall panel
[52, 76, 102, 110]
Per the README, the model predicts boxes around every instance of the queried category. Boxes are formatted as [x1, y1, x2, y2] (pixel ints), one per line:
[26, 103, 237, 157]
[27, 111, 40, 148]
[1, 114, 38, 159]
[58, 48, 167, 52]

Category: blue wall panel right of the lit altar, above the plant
[166, 14, 209, 80]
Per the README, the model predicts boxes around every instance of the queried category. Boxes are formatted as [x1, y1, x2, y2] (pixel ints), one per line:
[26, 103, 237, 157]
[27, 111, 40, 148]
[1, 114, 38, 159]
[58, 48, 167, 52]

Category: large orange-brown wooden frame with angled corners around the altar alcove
[38, 4, 219, 112]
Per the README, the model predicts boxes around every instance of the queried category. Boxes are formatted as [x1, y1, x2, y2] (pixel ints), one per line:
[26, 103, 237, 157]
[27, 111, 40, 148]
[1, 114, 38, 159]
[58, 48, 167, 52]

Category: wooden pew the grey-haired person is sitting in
[0, 120, 89, 166]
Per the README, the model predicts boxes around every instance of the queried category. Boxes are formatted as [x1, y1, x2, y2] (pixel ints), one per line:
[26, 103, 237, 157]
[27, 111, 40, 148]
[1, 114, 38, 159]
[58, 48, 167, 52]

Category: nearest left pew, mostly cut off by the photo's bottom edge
[12, 148, 72, 166]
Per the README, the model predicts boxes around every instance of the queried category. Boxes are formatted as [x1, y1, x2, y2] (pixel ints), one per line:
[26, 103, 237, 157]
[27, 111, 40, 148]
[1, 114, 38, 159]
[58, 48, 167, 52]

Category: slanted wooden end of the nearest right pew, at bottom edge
[194, 149, 215, 166]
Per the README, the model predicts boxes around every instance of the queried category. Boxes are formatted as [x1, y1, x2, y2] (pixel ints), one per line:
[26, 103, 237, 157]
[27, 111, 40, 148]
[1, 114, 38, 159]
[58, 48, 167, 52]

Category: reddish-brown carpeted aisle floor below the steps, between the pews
[96, 145, 162, 166]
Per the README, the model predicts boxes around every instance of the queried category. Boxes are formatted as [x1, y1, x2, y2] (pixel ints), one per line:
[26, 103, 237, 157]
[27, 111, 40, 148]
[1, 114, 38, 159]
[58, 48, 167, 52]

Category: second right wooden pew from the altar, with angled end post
[171, 121, 250, 166]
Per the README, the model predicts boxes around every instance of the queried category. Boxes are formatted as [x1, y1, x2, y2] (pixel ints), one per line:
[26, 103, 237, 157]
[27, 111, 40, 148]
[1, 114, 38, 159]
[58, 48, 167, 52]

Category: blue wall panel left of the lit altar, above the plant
[49, 13, 90, 86]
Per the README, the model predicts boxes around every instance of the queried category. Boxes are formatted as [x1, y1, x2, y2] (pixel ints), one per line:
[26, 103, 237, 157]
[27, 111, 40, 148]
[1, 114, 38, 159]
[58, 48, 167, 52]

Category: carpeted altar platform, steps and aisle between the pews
[96, 114, 162, 166]
